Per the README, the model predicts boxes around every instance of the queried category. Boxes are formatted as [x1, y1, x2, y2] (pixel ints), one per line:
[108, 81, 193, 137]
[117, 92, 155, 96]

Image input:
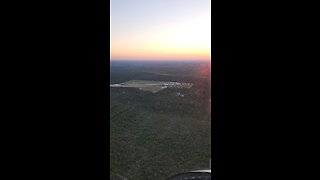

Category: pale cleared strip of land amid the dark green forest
[110, 80, 193, 93]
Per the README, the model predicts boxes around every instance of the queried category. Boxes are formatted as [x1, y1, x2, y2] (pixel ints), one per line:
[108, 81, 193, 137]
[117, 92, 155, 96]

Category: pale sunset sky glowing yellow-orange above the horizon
[110, 0, 211, 60]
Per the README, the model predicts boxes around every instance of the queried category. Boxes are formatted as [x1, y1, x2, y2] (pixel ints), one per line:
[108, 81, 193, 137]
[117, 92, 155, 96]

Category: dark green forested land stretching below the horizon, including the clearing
[110, 61, 211, 180]
